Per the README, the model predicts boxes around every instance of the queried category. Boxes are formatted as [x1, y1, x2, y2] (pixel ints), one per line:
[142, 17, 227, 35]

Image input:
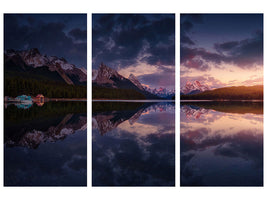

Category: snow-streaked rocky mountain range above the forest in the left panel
[4, 48, 87, 85]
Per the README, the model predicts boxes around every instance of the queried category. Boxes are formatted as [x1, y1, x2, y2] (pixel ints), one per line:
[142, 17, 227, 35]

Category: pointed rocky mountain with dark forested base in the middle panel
[92, 63, 175, 99]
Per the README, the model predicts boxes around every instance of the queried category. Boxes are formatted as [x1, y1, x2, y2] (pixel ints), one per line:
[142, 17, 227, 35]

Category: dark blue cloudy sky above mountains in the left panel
[4, 14, 87, 68]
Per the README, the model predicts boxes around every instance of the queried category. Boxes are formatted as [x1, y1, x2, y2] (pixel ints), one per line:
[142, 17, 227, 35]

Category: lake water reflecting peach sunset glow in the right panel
[180, 102, 263, 186]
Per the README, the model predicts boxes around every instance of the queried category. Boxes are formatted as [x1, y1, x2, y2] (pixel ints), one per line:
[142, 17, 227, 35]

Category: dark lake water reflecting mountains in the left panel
[4, 102, 87, 186]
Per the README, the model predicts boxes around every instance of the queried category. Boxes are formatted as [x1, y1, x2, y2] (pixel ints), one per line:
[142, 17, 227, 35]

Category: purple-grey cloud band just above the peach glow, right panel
[181, 31, 263, 71]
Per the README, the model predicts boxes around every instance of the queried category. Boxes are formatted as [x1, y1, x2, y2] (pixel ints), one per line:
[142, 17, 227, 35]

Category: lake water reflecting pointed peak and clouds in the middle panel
[92, 101, 175, 186]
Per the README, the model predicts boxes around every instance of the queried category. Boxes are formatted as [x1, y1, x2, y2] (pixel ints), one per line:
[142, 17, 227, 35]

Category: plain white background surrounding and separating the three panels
[0, 0, 267, 200]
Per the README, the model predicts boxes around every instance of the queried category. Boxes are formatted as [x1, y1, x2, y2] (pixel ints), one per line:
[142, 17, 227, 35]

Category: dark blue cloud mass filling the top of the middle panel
[92, 14, 175, 69]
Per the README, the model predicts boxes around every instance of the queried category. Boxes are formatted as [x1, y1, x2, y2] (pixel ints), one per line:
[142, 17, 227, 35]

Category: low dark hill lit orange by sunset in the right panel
[181, 85, 263, 100]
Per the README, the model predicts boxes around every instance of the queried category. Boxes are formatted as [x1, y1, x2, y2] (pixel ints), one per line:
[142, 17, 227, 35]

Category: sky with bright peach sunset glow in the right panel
[180, 14, 263, 89]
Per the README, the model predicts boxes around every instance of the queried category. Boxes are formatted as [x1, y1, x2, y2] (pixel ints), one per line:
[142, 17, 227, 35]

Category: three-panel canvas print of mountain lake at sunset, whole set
[3, 13, 263, 187]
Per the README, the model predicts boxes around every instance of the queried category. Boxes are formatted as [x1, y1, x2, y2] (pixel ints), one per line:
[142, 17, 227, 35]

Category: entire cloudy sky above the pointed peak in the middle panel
[92, 14, 175, 89]
